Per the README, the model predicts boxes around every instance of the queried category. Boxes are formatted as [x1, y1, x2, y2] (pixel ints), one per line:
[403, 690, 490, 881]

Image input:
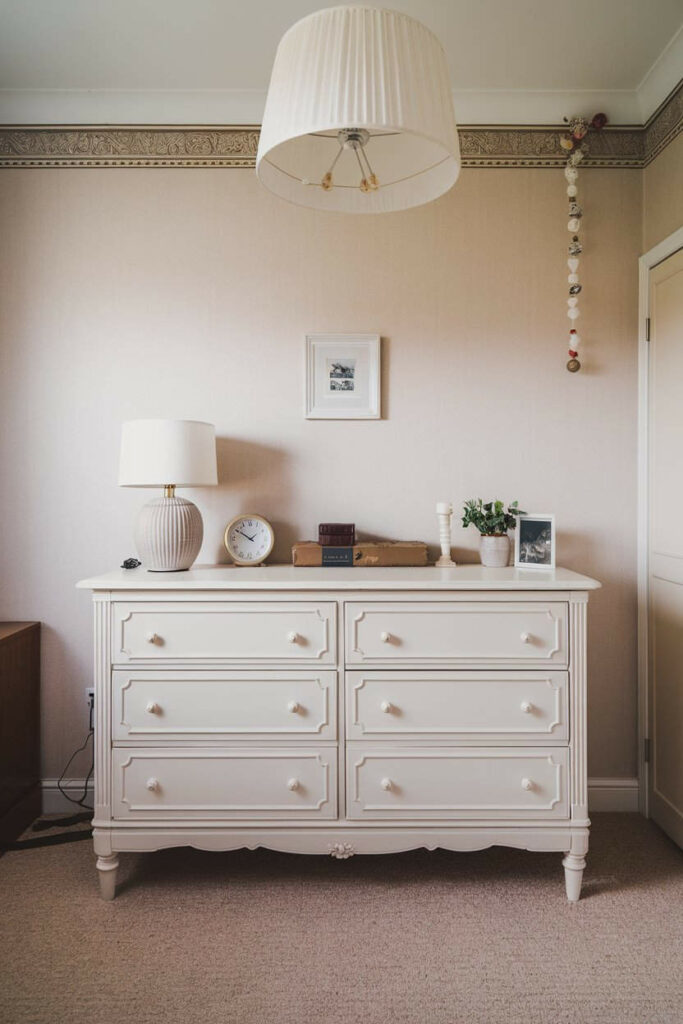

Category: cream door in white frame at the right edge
[648, 250, 683, 846]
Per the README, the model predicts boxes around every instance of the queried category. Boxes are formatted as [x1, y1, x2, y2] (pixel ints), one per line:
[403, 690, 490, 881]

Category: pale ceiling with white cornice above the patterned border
[0, 0, 683, 124]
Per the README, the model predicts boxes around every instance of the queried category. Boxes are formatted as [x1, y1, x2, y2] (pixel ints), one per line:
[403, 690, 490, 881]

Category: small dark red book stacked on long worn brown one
[292, 522, 427, 567]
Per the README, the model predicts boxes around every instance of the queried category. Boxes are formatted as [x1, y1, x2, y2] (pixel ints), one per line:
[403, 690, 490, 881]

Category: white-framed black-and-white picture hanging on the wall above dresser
[306, 334, 381, 420]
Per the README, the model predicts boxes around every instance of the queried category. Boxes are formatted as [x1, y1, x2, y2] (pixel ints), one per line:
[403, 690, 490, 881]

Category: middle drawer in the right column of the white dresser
[346, 669, 568, 743]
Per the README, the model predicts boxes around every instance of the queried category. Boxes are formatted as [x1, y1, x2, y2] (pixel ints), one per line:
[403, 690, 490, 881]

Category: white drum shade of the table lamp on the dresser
[119, 420, 218, 487]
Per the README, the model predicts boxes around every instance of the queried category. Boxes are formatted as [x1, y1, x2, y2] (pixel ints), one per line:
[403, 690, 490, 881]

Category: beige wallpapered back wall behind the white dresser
[0, 163, 641, 776]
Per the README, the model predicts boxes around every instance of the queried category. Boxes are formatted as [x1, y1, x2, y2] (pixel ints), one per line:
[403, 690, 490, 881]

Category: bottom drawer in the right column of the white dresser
[346, 743, 569, 820]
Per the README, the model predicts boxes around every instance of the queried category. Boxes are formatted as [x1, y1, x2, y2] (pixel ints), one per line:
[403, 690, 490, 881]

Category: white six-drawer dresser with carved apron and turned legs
[79, 565, 599, 900]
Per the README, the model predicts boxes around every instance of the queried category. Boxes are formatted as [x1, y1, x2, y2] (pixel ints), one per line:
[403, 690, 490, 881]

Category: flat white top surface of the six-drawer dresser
[77, 565, 601, 591]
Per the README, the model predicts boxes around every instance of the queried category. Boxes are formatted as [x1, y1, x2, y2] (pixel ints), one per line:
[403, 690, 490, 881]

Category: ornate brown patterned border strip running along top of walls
[0, 82, 683, 168]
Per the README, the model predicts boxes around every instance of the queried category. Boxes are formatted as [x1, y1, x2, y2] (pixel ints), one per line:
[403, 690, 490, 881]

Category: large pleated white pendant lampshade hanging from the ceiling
[256, 6, 460, 213]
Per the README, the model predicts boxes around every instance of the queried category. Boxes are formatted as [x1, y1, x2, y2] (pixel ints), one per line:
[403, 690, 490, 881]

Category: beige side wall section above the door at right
[643, 132, 683, 252]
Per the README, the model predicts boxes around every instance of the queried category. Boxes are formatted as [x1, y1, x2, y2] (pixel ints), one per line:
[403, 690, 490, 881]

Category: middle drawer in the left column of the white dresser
[113, 668, 337, 741]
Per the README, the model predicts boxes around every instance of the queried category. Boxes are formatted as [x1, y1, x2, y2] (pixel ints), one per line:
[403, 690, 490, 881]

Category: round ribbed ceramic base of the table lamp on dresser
[135, 497, 204, 572]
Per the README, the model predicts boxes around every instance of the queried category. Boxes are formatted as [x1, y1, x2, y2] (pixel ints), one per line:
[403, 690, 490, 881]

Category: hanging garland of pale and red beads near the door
[560, 114, 607, 374]
